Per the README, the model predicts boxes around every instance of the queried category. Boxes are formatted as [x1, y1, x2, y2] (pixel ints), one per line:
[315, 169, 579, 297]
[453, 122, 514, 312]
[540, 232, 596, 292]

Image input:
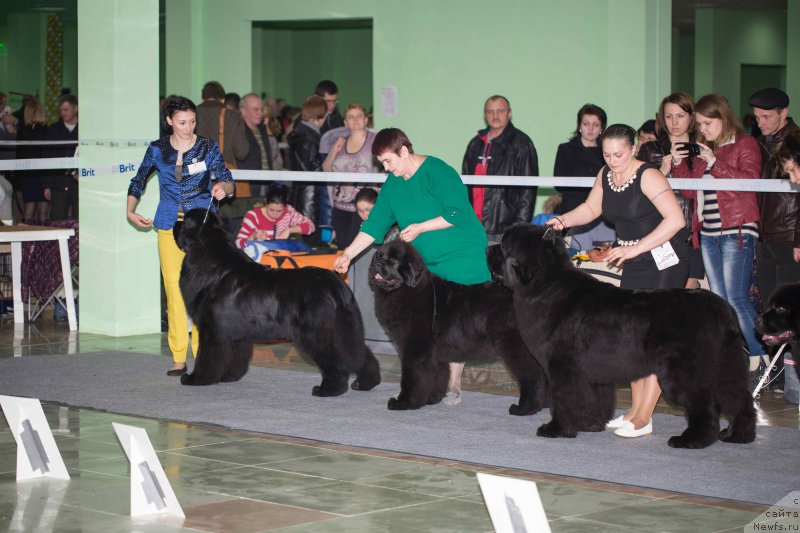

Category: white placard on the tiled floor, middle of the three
[112, 422, 185, 517]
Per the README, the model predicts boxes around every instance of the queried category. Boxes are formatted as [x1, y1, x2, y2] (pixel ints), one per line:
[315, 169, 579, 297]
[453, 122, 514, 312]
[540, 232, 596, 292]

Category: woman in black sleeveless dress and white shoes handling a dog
[547, 124, 689, 437]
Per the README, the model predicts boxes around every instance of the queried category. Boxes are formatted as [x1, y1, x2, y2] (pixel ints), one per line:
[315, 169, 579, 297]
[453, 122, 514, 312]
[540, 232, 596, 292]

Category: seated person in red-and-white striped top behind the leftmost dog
[236, 184, 314, 254]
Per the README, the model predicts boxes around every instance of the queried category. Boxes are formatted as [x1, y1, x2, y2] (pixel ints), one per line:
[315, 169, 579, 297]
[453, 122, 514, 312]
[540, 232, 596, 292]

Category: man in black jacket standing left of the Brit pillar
[44, 94, 78, 220]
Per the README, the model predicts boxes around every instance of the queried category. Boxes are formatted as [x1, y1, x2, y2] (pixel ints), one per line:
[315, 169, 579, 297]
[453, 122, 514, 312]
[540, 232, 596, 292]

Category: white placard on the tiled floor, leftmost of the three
[0, 396, 69, 481]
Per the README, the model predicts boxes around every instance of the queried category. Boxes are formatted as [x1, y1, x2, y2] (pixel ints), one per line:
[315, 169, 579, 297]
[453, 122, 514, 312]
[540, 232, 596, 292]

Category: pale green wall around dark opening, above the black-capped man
[694, 8, 788, 114]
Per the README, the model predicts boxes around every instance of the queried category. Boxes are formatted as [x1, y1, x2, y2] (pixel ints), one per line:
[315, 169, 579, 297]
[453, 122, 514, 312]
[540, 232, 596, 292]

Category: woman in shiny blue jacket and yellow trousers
[127, 96, 235, 376]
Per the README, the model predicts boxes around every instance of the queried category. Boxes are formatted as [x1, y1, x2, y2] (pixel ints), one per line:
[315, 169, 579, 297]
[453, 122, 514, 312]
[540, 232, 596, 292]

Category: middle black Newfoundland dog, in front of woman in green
[369, 240, 546, 415]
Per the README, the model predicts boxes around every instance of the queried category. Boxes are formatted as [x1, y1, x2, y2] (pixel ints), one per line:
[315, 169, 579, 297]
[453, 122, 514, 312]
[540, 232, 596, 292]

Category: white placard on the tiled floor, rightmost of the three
[478, 472, 550, 533]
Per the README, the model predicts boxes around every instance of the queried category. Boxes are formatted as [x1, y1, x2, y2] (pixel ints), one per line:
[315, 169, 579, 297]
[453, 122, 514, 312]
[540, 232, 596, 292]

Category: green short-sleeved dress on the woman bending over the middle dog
[361, 156, 491, 285]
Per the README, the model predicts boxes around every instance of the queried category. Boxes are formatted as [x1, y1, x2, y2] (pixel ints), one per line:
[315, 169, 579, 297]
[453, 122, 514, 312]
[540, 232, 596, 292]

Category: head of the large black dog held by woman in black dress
[496, 224, 570, 289]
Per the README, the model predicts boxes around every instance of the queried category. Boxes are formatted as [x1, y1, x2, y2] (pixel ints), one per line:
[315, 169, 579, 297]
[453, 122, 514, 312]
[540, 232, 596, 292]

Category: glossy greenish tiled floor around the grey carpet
[0, 317, 798, 533]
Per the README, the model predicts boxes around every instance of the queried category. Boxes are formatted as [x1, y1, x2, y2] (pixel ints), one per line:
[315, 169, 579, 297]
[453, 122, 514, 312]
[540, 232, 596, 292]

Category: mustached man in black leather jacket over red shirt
[462, 95, 539, 242]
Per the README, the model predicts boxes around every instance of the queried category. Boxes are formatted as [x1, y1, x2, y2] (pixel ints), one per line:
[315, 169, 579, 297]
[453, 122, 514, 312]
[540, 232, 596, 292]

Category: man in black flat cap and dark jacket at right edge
[747, 87, 800, 389]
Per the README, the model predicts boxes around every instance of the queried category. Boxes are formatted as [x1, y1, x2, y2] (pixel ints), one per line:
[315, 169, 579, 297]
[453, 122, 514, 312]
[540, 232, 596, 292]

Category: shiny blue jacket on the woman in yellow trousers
[128, 136, 235, 230]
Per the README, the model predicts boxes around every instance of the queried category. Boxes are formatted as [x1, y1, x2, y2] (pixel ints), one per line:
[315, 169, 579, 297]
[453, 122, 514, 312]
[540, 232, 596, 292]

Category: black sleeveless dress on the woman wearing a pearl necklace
[602, 164, 689, 289]
